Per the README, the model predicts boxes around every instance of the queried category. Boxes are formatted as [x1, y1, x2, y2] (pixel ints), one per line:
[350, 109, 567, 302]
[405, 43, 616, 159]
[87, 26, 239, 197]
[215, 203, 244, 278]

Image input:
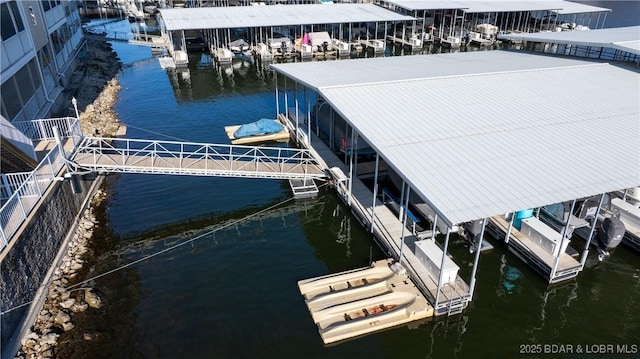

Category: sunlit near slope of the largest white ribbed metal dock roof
[277, 51, 640, 224]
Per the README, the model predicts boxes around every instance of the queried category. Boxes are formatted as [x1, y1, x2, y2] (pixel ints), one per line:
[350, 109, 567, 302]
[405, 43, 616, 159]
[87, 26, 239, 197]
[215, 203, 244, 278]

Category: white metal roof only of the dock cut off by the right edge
[498, 26, 640, 55]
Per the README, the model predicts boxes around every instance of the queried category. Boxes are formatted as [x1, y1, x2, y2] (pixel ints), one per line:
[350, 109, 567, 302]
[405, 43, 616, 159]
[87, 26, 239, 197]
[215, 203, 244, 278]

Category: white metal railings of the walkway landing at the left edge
[0, 117, 82, 251]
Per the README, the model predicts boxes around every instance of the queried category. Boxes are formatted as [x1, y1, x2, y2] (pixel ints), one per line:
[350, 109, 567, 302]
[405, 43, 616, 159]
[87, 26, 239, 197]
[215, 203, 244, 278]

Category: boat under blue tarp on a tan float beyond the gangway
[224, 118, 289, 145]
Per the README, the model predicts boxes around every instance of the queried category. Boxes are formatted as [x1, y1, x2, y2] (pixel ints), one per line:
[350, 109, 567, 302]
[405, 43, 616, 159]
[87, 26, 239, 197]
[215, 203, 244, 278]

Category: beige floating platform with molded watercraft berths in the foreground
[298, 259, 433, 344]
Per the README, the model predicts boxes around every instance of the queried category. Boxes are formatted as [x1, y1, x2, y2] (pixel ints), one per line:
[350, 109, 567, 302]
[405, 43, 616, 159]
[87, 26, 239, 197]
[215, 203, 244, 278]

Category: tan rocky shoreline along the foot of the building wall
[16, 31, 121, 358]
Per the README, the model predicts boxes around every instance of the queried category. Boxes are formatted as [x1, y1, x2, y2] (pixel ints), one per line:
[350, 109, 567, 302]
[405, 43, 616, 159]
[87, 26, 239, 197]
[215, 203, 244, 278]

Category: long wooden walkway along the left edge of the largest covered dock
[286, 117, 470, 315]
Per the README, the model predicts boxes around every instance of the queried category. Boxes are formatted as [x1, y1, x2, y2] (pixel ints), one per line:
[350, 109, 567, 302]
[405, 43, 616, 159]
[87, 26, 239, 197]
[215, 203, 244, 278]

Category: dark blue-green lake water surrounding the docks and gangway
[59, 1, 640, 358]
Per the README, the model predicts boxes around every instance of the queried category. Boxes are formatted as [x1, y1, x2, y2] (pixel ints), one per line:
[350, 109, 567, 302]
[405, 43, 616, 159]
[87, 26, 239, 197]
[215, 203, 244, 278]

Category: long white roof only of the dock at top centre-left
[160, 4, 413, 31]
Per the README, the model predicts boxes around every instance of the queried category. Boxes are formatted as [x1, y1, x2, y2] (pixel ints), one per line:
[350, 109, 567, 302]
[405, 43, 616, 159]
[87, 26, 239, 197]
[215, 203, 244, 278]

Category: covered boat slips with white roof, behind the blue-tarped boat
[160, 4, 414, 63]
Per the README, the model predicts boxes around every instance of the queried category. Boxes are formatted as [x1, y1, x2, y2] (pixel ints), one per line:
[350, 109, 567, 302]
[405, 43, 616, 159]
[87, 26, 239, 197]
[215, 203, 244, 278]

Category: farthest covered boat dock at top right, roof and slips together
[379, 0, 611, 44]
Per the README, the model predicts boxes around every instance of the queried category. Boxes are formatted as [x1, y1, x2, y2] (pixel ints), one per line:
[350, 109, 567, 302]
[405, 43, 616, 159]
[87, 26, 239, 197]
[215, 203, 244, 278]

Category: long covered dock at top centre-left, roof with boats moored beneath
[159, 4, 414, 63]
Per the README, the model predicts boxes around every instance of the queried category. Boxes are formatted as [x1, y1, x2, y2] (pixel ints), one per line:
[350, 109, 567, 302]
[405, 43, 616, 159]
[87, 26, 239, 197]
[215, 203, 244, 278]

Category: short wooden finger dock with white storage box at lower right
[488, 216, 582, 283]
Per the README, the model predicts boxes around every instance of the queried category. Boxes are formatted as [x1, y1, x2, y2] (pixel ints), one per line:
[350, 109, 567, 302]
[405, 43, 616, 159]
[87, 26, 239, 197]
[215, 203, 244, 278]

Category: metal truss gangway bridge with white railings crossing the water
[68, 137, 326, 183]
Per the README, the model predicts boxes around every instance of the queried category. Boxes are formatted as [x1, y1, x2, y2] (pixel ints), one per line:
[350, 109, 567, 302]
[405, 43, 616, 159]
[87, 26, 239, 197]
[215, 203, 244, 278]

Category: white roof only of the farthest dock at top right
[386, 0, 611, 14]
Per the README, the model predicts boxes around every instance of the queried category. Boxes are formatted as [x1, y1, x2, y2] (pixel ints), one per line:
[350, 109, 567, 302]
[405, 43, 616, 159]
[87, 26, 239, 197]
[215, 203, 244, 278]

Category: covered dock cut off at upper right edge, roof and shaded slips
[498, 26, 640, 62]
